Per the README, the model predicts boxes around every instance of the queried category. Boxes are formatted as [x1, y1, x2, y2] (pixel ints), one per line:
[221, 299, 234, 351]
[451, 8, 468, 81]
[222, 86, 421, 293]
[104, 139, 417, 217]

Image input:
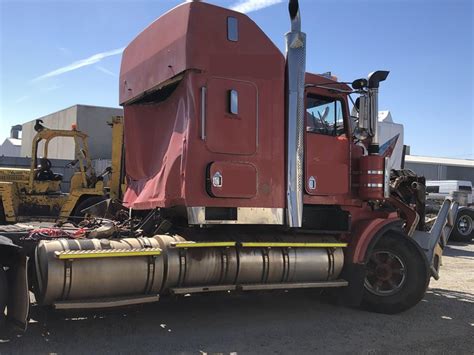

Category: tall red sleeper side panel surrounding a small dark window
[206, 78, 258, 155]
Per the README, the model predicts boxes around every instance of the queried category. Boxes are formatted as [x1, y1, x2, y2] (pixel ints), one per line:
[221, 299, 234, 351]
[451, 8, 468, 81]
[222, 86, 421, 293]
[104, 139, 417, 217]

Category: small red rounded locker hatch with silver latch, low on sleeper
[209, 162, 257, 198]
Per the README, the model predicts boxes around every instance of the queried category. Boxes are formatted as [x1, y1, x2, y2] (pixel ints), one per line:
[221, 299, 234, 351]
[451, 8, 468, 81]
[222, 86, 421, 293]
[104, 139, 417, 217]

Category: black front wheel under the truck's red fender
[362, 232, 430, 314]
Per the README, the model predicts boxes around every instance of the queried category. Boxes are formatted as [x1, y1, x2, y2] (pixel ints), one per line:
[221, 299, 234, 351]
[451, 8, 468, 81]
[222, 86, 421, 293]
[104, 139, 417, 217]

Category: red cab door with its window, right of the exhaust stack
[304, 93, 349, 196]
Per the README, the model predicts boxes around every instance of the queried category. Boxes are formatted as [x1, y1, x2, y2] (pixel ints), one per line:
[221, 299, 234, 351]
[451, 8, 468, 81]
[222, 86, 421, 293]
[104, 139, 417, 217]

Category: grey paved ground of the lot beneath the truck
[0, 244, 474, 354]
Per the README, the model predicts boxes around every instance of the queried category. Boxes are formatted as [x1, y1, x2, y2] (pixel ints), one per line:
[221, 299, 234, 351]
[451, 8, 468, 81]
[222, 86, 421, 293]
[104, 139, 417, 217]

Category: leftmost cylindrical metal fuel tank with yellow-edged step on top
[36, 238, 163, 305]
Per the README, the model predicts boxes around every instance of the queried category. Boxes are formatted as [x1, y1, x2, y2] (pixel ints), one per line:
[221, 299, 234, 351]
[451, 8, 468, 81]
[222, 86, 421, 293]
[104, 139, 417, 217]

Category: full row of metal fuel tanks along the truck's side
[36, 235, 344, 305]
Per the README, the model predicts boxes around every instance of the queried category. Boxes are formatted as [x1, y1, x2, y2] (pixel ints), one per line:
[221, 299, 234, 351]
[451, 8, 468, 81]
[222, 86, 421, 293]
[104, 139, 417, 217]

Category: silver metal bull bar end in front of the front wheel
[413, 200, 459, 280]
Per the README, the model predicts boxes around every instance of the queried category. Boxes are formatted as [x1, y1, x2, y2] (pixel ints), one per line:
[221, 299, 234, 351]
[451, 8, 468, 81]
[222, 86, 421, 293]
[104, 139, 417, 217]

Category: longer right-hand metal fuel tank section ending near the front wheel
[155, 236, 344, 292]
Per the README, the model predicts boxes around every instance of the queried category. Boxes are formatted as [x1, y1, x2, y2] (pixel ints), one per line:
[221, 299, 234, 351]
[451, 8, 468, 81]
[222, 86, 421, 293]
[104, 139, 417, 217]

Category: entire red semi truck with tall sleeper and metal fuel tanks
[0, 0, 457, 334]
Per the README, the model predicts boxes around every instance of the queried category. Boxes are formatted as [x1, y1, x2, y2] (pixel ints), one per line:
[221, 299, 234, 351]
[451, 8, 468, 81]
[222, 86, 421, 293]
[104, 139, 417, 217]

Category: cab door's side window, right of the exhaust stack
[306, 96, 344, 136]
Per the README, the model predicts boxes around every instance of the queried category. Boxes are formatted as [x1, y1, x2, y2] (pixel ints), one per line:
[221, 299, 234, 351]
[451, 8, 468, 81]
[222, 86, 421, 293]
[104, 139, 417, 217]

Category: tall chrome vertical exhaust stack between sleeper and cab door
[285, 0, 306, 228]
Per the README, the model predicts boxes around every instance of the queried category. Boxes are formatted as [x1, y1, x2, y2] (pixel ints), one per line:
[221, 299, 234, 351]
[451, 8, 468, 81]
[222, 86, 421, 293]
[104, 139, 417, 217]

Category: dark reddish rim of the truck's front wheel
[364, 250, 406, 296]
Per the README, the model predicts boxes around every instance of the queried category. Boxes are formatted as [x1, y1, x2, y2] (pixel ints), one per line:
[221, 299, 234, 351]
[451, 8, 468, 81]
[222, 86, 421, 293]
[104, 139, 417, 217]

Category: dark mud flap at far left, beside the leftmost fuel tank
[7, 255, 30, 331]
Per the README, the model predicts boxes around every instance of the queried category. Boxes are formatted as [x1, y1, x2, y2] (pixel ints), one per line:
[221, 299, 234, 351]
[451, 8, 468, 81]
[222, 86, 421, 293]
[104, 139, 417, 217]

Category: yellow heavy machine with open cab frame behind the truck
[0, 116, 123, 223]
